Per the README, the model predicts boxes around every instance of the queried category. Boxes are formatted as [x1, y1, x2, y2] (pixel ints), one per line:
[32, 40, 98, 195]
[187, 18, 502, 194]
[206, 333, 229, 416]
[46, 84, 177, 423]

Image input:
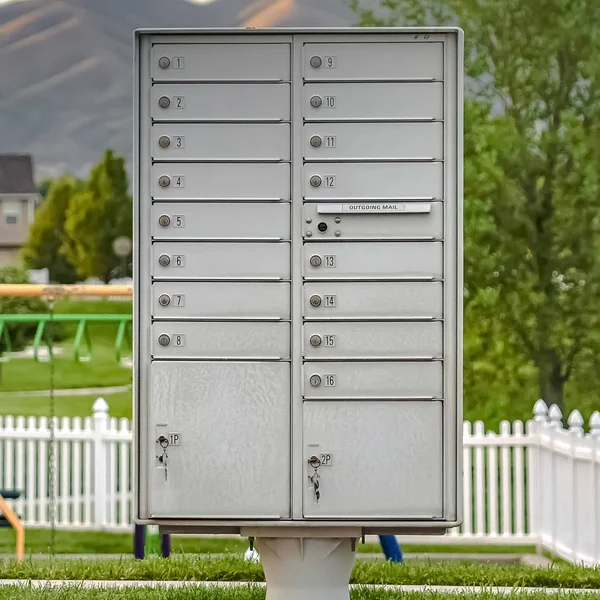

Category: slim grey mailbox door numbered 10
[302, 83, 444, 121]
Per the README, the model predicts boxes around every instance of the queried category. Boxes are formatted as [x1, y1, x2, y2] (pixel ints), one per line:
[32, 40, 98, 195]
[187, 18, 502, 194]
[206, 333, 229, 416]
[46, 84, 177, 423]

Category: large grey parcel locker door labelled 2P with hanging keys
[303, 401, 443, 519]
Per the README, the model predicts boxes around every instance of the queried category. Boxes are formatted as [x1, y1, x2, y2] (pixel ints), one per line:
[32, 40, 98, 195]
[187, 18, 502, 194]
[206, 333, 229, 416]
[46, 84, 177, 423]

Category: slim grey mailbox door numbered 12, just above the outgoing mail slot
[303, 162, 444, 200]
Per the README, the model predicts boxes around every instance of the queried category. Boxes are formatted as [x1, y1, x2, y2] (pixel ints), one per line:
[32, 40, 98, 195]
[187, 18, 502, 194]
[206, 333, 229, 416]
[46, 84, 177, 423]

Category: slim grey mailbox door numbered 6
[152, 242, 290, 279]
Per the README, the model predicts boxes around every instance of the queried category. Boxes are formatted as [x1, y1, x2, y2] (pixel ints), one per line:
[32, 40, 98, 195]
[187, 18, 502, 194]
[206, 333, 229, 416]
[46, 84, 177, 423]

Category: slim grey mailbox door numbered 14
[303, 281, 443, 320]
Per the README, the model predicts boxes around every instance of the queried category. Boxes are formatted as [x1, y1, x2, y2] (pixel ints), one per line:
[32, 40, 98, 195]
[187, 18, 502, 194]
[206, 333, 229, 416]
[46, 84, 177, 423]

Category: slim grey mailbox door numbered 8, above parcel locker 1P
[152, 321, 290, 360]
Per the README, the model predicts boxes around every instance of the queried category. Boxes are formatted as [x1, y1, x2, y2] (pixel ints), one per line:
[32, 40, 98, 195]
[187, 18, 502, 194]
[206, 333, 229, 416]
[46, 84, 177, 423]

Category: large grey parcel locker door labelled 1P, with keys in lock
[149, 361, 290, 518]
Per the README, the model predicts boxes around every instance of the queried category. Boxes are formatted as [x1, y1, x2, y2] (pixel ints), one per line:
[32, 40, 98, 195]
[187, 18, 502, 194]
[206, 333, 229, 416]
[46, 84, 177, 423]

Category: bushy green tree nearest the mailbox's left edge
[62, 150, 133, 282]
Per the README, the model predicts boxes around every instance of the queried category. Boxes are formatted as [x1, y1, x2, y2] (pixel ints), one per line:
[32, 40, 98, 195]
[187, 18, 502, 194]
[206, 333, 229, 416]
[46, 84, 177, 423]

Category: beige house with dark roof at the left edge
[0, 154, 41, 267]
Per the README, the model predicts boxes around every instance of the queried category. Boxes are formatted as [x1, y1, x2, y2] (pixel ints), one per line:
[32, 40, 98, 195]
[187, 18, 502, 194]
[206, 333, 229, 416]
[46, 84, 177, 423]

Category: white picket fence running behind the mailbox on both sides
[0, 398, 600, 565]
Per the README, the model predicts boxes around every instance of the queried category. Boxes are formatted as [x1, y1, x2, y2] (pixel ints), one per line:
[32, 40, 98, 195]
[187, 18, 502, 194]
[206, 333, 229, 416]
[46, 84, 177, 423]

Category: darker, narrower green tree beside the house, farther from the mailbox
[21, 177, 78, 283]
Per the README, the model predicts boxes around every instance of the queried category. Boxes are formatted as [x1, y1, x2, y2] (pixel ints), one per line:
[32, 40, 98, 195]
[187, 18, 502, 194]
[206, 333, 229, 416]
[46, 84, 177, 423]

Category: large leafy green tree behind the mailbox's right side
[351, 0, 600, 406]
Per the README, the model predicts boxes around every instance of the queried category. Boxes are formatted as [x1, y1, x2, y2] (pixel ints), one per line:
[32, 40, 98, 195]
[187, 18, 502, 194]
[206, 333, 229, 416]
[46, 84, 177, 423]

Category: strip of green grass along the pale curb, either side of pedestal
[0, 554, 600, 590]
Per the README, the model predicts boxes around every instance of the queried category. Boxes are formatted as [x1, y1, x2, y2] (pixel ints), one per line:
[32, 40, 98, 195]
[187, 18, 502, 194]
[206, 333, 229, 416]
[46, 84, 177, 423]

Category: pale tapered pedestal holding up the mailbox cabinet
[256, 537, 356, 600]
